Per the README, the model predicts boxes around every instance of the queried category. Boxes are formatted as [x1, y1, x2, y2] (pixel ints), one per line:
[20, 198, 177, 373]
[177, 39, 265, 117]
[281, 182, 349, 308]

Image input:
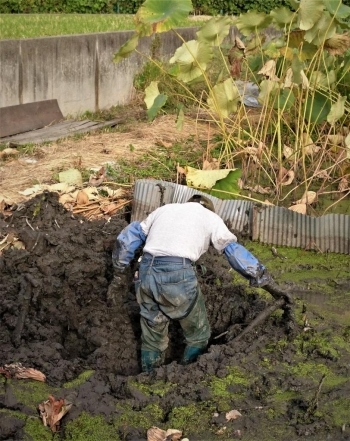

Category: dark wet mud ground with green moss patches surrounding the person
[0, 194, 350, 441]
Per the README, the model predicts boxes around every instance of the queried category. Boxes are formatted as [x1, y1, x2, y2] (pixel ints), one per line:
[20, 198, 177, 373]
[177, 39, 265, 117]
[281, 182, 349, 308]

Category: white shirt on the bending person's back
[141, 202, 237, 262]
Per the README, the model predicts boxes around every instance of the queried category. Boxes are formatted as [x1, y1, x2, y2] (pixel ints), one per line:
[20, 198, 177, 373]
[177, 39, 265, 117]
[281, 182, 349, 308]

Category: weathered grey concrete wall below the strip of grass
[0, 28, 216, 115]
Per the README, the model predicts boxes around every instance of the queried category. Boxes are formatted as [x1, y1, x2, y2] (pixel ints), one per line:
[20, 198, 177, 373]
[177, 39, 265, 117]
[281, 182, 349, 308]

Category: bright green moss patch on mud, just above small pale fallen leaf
[209, 367, 251, 399]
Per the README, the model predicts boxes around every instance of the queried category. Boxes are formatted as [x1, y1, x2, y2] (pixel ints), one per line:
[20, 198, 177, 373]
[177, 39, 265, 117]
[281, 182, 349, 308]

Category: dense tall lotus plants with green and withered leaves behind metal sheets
[115, 0, 350, 213]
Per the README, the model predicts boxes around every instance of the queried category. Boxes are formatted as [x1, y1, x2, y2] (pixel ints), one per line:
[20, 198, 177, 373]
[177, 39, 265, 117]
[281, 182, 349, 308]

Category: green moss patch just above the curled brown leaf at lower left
[7, 380, 58, 410]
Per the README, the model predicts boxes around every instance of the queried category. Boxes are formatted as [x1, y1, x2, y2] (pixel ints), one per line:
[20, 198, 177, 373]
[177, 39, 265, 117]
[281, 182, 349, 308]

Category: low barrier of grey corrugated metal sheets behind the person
[132, 179, 350, 254]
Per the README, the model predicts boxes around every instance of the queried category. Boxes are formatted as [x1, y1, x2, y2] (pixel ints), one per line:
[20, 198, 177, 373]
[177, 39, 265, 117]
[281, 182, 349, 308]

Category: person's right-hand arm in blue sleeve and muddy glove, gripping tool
[224, 242, 293, 303]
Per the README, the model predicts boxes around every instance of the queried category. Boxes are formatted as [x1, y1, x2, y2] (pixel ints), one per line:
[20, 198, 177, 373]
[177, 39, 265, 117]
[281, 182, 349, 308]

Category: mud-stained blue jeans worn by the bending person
[135, 253, 210, 352]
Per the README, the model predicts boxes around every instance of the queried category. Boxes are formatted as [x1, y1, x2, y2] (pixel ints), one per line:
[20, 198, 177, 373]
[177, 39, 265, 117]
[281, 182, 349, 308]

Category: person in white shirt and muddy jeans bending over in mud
[107, 195, 290, 372]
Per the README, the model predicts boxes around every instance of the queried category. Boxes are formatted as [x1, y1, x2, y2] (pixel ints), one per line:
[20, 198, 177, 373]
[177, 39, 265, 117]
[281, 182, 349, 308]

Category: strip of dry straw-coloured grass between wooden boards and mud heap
[0, 115, 212, 203]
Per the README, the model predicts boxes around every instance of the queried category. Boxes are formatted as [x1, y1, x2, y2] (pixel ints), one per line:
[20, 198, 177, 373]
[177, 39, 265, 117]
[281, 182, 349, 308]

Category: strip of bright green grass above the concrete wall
[0, 14, 209, 40]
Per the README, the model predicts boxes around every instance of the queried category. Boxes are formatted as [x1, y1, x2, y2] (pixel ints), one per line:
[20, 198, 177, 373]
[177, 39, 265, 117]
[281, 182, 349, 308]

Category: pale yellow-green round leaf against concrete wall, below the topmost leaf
[170, 40, 213, 83]
